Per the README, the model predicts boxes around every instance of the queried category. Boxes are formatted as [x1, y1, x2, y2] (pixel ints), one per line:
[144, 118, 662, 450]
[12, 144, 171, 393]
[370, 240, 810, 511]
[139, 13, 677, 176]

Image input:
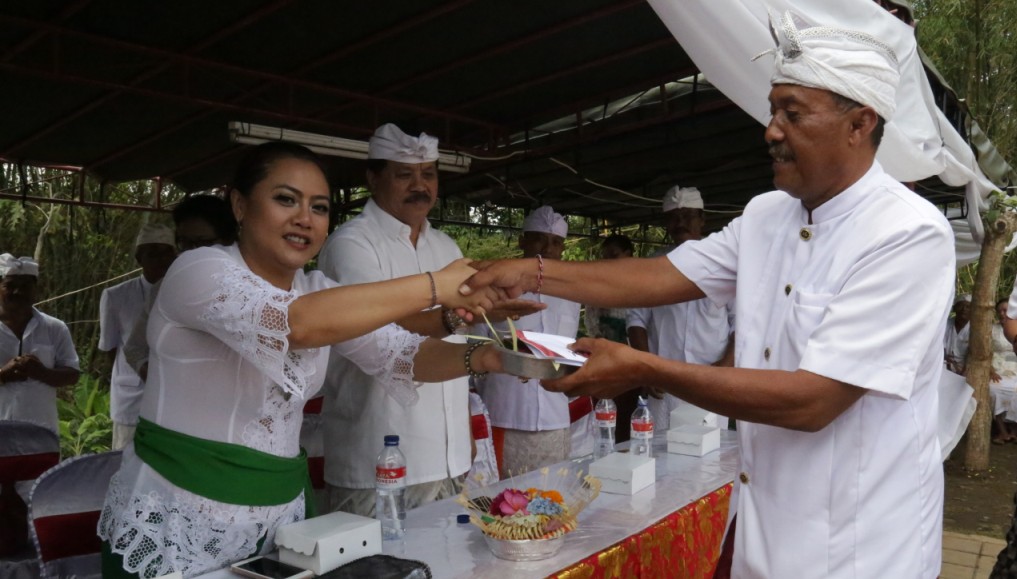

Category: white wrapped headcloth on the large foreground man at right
[754, 12, 900, 121]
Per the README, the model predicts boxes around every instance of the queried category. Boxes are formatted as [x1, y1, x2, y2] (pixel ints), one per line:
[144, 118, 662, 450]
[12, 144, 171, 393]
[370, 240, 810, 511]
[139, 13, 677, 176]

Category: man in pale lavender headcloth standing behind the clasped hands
[477, 206, 580, 478]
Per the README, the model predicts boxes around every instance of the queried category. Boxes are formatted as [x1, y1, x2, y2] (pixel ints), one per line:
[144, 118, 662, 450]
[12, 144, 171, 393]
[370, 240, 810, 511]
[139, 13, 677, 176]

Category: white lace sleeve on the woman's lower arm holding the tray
[333, 324, 427, 406]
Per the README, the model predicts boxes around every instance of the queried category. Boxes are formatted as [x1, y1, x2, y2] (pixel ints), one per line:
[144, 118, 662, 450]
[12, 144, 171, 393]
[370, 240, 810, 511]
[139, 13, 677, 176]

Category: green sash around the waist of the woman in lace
[134, 418, 314, 518]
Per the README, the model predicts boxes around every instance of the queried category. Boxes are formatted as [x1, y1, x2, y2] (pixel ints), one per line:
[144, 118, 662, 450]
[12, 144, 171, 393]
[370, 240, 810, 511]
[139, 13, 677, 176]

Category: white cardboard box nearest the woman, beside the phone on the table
[276, 512, 381, 575]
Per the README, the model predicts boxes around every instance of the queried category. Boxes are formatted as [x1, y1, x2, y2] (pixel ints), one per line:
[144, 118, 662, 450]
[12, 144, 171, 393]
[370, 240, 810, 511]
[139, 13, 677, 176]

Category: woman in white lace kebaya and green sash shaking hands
[99, 142, 500, 577]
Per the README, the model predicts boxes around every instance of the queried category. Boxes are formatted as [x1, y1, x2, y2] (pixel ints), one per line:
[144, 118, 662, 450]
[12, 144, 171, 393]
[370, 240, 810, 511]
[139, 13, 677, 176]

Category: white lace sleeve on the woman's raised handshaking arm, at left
[157, 249, 315, 398]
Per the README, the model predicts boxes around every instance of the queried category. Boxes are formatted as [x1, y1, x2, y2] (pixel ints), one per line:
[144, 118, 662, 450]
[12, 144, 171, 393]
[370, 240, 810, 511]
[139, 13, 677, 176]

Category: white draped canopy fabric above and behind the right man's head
[648, 0, 1000, 265]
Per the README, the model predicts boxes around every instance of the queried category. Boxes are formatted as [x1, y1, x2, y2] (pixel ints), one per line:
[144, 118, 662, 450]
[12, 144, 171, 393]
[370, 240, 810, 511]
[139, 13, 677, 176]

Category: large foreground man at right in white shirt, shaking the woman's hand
[468, 10, 955, 579]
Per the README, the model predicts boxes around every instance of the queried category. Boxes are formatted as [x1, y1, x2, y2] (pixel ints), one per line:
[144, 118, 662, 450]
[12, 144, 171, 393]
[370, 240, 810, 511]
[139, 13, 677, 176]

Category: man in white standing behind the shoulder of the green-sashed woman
[99, 224, 177, 450]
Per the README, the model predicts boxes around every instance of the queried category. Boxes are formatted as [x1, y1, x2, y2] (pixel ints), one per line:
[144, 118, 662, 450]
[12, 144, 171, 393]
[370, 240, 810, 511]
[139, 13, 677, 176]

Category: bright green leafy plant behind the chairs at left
[57, 373, 113, 458]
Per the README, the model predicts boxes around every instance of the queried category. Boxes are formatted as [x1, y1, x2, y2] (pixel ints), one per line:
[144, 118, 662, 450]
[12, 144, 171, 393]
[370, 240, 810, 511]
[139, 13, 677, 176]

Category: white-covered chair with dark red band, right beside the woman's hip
[28, 451, 121, 578]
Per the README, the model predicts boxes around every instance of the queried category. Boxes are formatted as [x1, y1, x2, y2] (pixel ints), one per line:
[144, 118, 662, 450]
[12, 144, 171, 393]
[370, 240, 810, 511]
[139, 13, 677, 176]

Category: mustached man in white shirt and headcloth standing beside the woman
[317, 124, 472, 516]
